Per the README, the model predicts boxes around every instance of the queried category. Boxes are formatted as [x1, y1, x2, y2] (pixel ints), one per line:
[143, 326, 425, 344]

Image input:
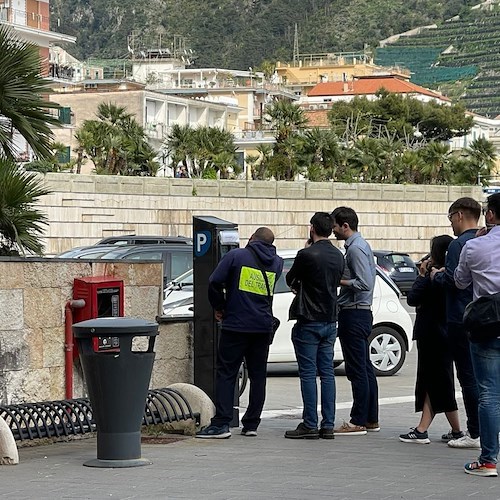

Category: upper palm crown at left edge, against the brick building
[0, 25, 59, 159]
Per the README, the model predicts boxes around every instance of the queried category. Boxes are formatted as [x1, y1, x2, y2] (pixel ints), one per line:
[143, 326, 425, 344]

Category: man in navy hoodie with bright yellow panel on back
[196, 227, 283, 439]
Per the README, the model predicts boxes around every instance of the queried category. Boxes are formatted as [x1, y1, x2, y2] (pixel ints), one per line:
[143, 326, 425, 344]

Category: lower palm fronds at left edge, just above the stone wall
[0, 158, 49, 255]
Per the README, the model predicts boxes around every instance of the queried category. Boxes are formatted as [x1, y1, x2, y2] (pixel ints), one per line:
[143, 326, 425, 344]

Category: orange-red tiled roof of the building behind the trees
[308, 75, 449, 101]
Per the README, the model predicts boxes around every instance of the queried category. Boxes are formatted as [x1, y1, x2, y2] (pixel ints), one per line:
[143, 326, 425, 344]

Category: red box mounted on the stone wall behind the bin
[73, 276, 124, 358]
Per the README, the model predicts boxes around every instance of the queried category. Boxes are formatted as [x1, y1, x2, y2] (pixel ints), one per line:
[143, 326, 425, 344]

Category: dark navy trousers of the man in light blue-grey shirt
[338, 309, 378, 425]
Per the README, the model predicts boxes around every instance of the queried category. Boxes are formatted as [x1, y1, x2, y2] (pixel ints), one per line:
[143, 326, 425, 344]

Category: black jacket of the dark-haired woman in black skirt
[406, 275, 446, 340]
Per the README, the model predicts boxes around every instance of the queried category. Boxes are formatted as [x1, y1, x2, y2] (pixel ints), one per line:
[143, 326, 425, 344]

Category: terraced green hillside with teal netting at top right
[375, 4, 500, 118]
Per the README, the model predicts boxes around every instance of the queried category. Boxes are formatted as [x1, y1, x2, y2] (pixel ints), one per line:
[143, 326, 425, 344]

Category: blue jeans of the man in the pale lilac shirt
[470, 338, 500, 464]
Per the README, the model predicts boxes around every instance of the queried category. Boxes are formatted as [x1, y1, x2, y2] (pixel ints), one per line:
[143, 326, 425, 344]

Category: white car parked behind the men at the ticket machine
[163, 250, 413, 375]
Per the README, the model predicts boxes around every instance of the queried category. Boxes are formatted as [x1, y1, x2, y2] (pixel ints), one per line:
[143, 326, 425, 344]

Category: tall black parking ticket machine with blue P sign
[193, 216, 240, 418]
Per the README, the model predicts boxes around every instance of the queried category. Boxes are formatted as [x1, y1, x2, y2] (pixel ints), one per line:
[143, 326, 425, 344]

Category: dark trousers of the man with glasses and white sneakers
[447, 323, 479, 438]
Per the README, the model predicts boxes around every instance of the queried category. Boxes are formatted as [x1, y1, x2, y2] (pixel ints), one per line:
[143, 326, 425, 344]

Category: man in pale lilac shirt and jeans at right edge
[455, 193, 500, 477]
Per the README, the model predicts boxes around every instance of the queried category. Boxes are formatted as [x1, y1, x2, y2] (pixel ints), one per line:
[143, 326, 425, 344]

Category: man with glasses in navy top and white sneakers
[431, 197, 481, 448]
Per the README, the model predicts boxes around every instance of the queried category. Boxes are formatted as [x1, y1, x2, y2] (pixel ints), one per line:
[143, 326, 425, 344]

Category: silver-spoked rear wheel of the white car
[368, 326, 406, 377]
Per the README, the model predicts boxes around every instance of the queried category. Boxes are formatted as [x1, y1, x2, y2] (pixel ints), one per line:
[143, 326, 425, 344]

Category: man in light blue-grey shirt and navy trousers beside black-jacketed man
[331, 207, 380, 436]
